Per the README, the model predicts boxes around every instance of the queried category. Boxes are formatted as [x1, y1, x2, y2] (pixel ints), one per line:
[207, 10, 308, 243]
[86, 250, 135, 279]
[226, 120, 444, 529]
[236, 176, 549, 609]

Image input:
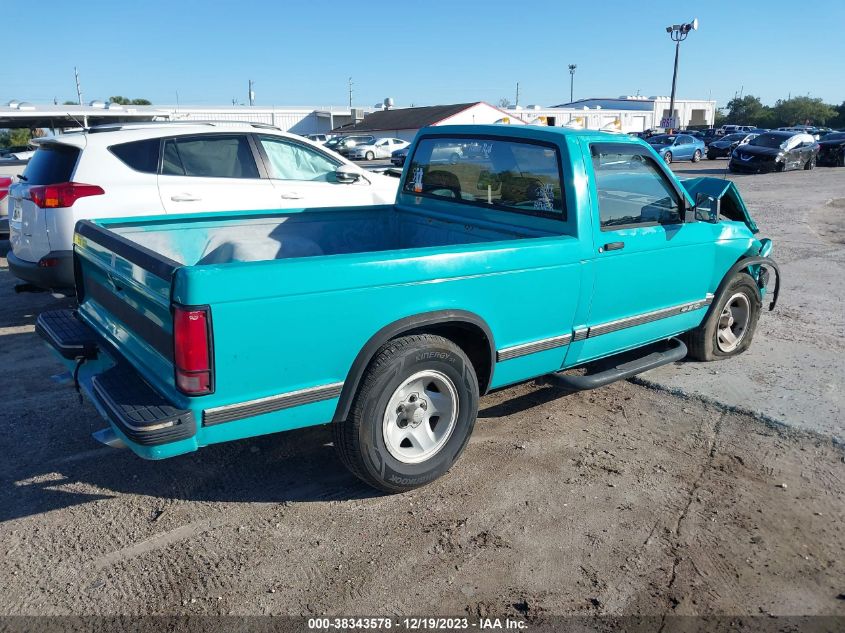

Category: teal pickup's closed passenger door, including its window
[567, 143, 718, 365]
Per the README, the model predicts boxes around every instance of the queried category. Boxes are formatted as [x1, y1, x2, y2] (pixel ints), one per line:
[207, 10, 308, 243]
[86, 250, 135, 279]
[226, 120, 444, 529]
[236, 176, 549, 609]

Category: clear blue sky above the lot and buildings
[0, 0, 845, 106]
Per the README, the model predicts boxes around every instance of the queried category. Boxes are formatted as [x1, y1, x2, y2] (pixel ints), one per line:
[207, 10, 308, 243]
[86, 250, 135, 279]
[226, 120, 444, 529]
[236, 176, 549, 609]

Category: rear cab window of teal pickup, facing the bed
[402, 136, 566, 221]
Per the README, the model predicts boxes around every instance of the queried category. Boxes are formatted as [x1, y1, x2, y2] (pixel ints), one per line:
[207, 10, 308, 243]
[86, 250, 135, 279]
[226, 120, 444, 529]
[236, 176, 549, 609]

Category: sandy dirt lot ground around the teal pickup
[0, 163, 845, 619]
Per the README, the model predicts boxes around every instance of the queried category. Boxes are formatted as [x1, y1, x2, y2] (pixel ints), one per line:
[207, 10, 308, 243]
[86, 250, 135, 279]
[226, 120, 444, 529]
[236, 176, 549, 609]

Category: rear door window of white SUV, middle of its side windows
[161, 134, 258, 178]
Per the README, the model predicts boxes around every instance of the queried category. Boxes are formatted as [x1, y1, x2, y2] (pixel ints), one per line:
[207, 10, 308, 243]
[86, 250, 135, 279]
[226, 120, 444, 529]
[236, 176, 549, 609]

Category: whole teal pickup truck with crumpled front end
[37, 125, 780, 492]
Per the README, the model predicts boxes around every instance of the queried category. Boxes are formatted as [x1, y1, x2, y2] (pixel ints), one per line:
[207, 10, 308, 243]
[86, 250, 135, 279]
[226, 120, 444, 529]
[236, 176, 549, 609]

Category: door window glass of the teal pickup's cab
[591, 143, 681, 231]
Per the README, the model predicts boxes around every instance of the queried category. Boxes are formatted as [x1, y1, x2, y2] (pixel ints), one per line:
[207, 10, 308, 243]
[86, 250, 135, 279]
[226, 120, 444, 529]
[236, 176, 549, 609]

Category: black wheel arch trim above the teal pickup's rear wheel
[332, 310, 496, 422]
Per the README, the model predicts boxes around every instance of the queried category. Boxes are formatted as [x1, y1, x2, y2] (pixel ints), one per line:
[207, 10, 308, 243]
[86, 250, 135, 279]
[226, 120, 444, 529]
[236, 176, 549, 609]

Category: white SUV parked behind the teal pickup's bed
[7, 122, 399, 289]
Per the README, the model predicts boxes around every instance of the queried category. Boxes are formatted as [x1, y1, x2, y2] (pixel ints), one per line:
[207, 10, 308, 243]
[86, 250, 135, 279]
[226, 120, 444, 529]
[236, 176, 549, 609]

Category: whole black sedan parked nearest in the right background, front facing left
[728, 131, 819, 173]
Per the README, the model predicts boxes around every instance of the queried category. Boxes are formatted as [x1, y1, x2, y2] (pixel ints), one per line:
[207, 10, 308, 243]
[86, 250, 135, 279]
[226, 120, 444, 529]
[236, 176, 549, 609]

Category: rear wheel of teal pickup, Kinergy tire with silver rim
[332, 334, 479, 493]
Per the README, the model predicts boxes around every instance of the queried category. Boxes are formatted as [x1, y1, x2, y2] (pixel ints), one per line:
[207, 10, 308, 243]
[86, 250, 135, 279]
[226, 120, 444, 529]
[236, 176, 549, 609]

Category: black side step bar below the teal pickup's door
[546, 338, 687, 391]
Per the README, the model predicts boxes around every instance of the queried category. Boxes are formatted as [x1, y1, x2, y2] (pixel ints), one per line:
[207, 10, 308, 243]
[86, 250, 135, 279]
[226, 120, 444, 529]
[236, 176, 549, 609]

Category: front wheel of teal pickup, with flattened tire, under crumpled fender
[686, 273, 762, 361]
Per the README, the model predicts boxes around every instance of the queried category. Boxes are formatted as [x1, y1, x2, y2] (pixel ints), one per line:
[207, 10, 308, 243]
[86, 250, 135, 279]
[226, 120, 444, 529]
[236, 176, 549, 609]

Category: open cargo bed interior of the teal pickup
[110, 206, 550, 266]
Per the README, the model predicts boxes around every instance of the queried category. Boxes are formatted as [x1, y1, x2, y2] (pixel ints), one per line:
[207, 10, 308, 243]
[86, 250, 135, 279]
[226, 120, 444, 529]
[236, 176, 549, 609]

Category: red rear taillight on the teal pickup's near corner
[173, 306, 214, 396]
